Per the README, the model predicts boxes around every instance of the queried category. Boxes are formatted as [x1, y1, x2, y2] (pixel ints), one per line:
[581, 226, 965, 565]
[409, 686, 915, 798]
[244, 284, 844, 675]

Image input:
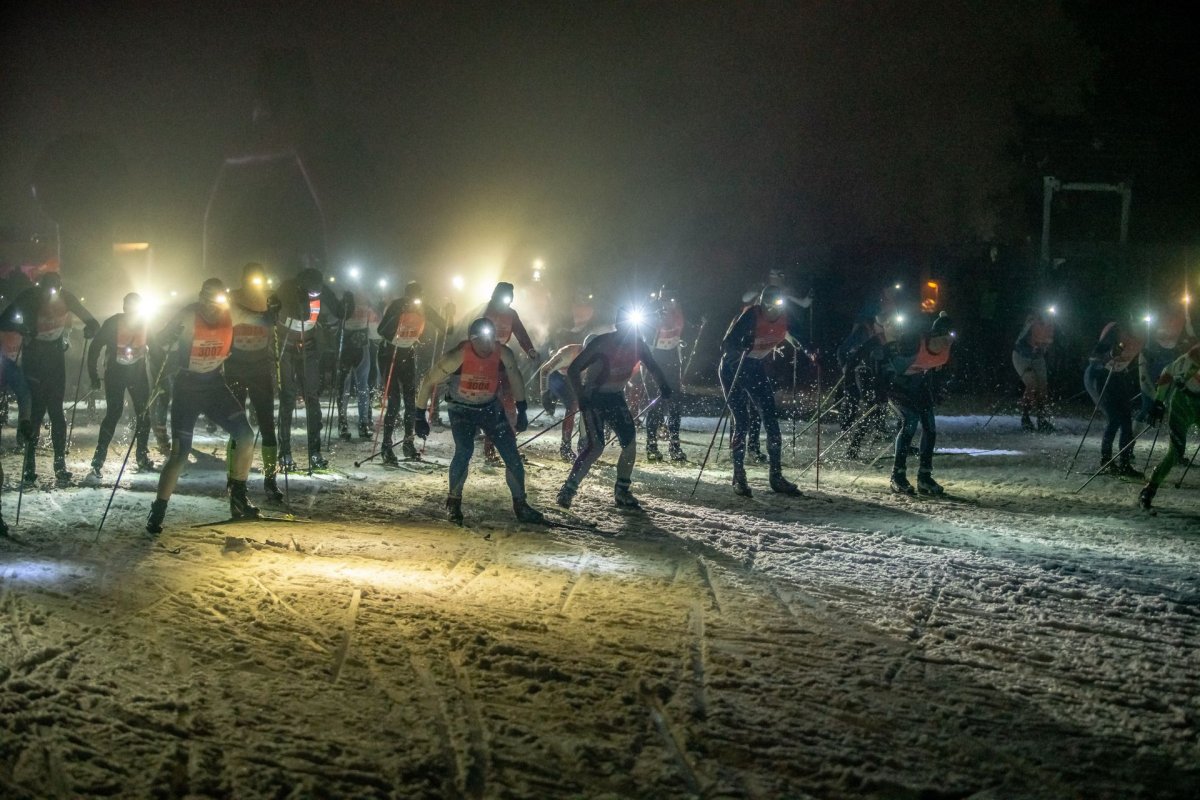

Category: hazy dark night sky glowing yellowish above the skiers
[0, 2, 1093, 299]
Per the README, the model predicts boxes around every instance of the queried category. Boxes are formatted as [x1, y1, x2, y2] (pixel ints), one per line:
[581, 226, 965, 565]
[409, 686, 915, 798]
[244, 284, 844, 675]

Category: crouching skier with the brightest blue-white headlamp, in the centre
[558, 308, 672, 509]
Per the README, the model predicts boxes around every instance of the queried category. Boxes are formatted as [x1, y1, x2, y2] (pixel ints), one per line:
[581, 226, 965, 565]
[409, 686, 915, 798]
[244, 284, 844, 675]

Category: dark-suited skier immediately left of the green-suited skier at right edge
[1084, 323, 1145, 477]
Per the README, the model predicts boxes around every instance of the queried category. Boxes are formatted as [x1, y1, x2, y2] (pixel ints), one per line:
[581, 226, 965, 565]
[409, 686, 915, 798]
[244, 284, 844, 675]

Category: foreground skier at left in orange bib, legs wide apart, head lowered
[146, 278, 258, 534]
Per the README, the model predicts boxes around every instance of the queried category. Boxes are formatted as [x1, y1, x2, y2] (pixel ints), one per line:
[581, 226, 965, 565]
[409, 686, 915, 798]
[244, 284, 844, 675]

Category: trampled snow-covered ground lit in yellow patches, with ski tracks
[0, 417, 1200, 799]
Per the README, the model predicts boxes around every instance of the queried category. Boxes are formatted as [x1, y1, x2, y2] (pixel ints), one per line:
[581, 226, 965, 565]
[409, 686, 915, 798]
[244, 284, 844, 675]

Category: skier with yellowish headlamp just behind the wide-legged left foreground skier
[224, 263, 283, 503]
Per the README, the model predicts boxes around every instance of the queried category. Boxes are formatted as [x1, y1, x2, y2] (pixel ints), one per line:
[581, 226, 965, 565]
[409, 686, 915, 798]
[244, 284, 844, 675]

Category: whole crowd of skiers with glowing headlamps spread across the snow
[0, 263, 1200, 533]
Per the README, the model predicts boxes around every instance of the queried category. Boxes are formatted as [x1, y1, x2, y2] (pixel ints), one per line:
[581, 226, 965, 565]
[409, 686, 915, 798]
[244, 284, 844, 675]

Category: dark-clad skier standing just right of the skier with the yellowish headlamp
[276, 267, 343, 471]
